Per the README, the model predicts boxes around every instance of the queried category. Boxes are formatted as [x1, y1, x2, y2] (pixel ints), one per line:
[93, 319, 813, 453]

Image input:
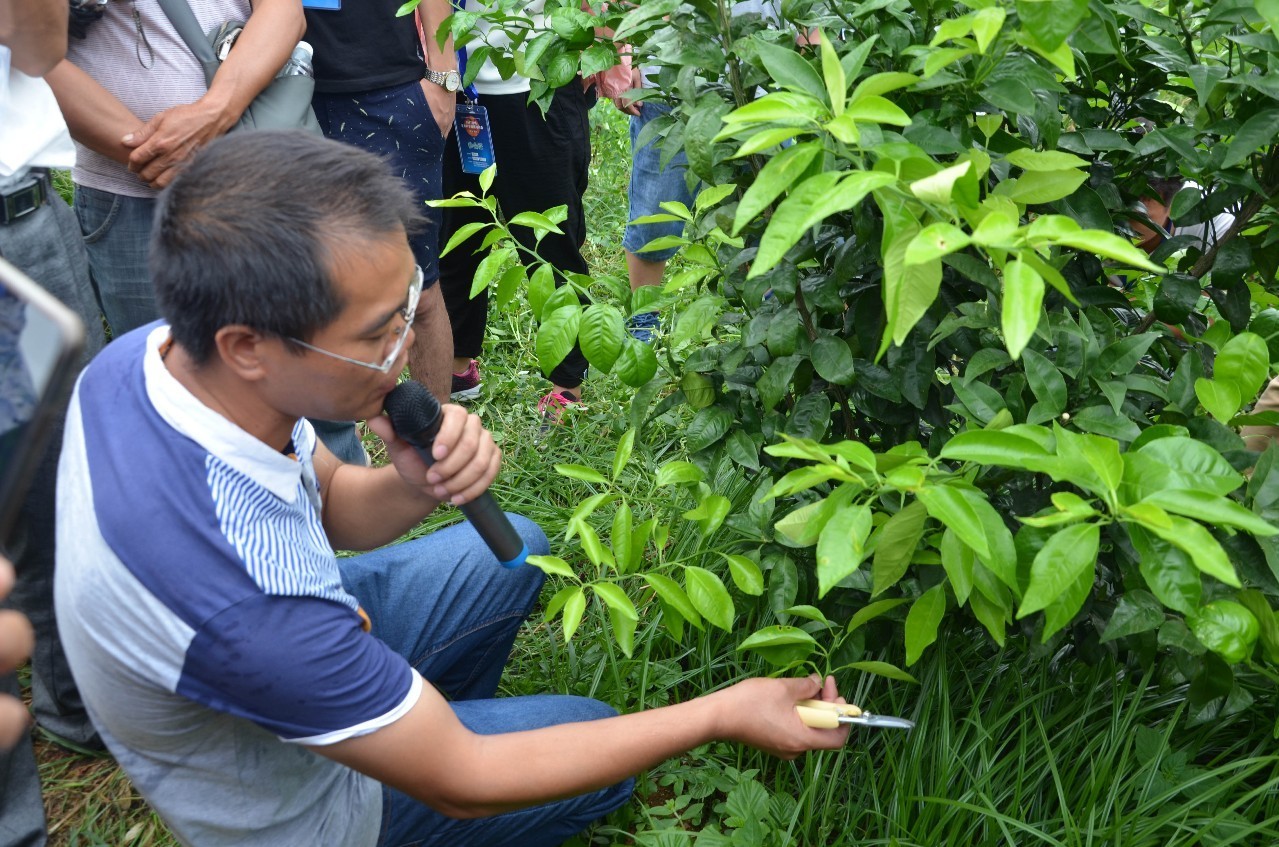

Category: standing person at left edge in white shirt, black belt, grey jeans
[0, 0, 102, 847]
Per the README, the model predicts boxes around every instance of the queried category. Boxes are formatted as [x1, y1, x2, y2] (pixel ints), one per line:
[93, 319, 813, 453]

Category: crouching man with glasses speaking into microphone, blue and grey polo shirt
[58, 132, 845, 847]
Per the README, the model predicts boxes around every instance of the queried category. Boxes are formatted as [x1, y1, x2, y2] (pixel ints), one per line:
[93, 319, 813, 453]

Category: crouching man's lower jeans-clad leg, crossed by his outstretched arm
[377, 696, 634, 847]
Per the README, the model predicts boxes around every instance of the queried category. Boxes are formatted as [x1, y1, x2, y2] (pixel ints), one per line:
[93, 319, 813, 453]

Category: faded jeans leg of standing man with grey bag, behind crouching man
[75, 186, 160, 338]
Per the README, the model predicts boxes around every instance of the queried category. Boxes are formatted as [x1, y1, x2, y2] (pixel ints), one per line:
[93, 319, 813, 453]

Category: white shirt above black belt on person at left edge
[0, 45, 75, 179]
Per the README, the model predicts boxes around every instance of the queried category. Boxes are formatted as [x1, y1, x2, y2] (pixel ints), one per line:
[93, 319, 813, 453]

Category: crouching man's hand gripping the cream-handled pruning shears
[707, 674, 849, 759]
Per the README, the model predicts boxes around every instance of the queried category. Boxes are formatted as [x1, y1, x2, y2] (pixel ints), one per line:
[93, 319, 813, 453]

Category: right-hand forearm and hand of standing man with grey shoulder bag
[124, 0, 306, 188]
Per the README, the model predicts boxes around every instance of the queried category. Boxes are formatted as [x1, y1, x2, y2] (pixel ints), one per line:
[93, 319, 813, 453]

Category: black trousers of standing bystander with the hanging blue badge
[440, 79, 595, 388]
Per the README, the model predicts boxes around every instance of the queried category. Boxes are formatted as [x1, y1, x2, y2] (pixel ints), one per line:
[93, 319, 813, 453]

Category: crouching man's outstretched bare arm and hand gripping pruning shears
[312, 677, 848, 818]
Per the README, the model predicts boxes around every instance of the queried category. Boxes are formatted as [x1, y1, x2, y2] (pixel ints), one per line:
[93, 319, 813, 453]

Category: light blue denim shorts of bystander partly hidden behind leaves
[622, 101, 701, 262]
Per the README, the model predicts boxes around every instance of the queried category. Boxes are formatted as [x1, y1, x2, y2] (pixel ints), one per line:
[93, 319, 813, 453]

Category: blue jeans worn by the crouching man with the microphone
[339, 516, 633, 847]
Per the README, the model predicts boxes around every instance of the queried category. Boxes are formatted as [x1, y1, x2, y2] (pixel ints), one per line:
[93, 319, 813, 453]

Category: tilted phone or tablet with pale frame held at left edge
[0, 258, 84, 549]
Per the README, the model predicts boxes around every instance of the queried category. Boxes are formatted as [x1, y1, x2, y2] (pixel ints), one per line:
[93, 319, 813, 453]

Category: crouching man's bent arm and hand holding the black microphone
[315, 403, 501, 550]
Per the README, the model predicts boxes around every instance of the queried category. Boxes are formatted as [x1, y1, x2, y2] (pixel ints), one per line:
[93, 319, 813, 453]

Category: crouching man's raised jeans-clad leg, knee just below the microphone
[339, 514, 549, 700]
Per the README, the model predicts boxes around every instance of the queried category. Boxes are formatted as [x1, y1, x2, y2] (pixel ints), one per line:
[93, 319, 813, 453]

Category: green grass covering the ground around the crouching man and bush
[27, 104, 1279, 847]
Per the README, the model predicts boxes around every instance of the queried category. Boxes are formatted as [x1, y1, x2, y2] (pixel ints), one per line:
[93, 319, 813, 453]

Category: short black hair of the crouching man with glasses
[150, 131, 423, 365]
